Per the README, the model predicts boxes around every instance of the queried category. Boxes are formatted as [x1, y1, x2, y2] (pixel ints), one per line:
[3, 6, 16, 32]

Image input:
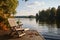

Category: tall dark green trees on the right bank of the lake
[36, 6, 60, 23]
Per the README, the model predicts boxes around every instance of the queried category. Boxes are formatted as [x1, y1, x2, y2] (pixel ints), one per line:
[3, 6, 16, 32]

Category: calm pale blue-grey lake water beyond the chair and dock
[16, 18, 60, 40]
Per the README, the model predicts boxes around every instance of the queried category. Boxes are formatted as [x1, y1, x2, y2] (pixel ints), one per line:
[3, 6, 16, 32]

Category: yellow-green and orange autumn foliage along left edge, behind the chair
[0, 0, 18, 27]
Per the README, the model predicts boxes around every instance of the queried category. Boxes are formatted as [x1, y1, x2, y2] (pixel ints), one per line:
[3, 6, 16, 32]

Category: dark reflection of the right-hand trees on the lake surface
[36, 19, 60, 28]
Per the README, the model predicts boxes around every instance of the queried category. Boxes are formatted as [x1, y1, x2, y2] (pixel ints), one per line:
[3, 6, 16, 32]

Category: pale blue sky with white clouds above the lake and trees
[16, 0, 60, 16]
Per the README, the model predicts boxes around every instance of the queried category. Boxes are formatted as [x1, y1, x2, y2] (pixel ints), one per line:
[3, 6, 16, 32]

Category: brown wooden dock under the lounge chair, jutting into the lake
[2, 30, 45, 40]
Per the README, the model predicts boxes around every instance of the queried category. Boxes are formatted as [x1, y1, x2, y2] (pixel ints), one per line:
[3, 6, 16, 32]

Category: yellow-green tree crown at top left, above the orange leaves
[0, 0, 18, 14]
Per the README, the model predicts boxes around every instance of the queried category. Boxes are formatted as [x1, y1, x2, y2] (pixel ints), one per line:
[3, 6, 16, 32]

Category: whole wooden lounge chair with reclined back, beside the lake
[8, 18, 29, 37]
